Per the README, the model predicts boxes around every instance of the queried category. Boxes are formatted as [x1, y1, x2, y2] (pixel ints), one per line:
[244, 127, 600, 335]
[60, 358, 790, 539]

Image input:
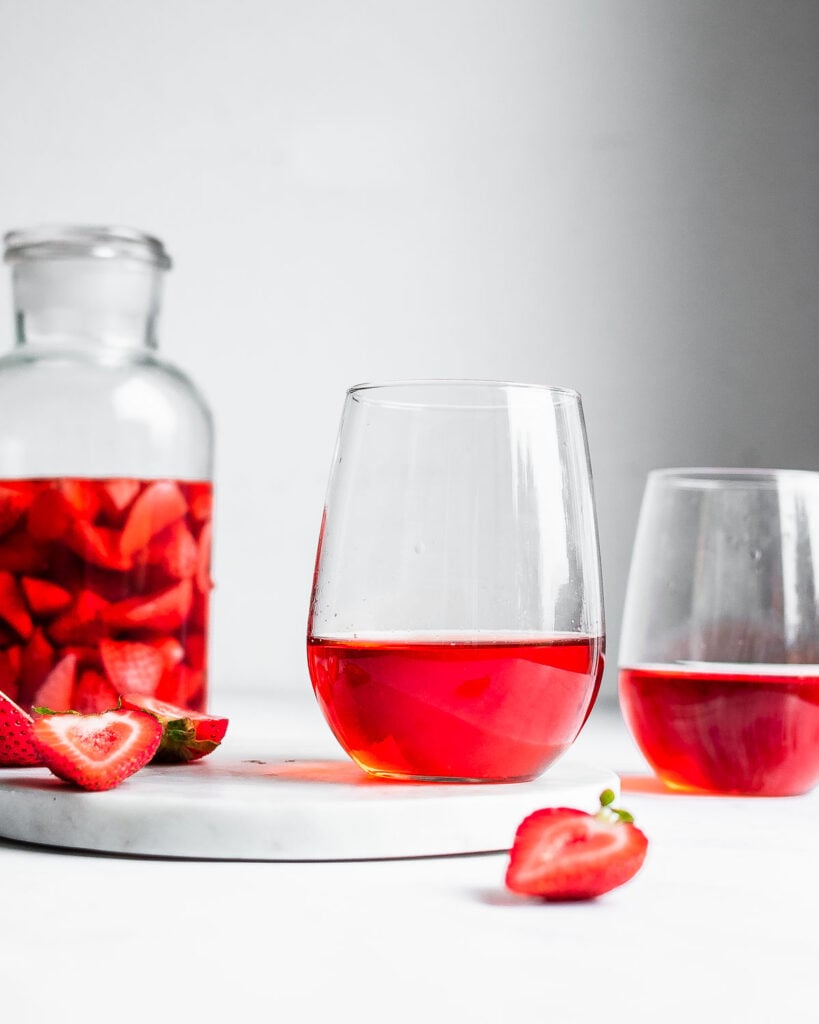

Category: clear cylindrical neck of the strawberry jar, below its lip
[12, 257, 163, 349]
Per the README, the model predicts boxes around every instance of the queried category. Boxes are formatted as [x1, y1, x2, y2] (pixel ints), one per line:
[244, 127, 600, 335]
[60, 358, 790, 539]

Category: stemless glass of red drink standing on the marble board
[307, 381, 604, 781]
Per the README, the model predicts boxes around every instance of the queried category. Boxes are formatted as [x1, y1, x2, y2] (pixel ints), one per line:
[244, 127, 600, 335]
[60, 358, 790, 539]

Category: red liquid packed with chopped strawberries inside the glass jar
[0, 478, 212, 713]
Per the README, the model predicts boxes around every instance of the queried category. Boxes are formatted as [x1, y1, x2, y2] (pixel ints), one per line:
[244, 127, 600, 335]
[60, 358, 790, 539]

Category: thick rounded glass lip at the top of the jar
[3, 224, 171, 270]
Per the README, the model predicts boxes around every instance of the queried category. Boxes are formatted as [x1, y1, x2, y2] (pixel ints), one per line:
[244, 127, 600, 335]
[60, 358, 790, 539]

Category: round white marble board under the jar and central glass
[0, 750, 619, 860]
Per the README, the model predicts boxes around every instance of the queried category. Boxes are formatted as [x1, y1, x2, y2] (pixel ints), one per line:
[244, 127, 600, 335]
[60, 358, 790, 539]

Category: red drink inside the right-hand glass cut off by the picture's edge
[619, 666, 819, 796]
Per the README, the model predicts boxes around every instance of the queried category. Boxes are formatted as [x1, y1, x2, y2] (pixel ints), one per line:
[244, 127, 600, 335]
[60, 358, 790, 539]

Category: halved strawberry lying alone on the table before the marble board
[506, 790, 648, 901]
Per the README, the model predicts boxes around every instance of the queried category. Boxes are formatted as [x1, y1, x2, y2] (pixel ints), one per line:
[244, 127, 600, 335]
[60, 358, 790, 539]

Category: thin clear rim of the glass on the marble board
[347, 377, 580, 409]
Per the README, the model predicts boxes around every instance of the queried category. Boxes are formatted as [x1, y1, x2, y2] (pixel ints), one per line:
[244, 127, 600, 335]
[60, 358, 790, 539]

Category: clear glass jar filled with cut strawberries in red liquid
[0, 226, 213, 713]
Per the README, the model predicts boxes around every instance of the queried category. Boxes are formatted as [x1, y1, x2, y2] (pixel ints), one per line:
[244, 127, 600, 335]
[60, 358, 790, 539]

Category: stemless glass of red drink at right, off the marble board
[619, 469, 819, 796]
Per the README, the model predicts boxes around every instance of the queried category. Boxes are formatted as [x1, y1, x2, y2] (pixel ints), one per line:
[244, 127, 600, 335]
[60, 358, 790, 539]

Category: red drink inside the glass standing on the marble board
[307, 637, 603, 781]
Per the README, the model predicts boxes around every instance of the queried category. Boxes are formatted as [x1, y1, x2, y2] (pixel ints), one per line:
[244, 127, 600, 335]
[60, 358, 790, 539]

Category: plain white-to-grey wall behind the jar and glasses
[0, 0, 819, 693]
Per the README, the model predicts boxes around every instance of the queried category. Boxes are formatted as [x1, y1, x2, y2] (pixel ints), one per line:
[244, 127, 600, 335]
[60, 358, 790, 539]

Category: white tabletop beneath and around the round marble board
[0, 695, 819, 1024]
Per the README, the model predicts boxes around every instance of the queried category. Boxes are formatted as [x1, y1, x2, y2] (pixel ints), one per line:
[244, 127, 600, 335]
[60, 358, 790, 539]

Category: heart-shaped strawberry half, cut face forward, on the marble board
[33, 710, 162, 791]
